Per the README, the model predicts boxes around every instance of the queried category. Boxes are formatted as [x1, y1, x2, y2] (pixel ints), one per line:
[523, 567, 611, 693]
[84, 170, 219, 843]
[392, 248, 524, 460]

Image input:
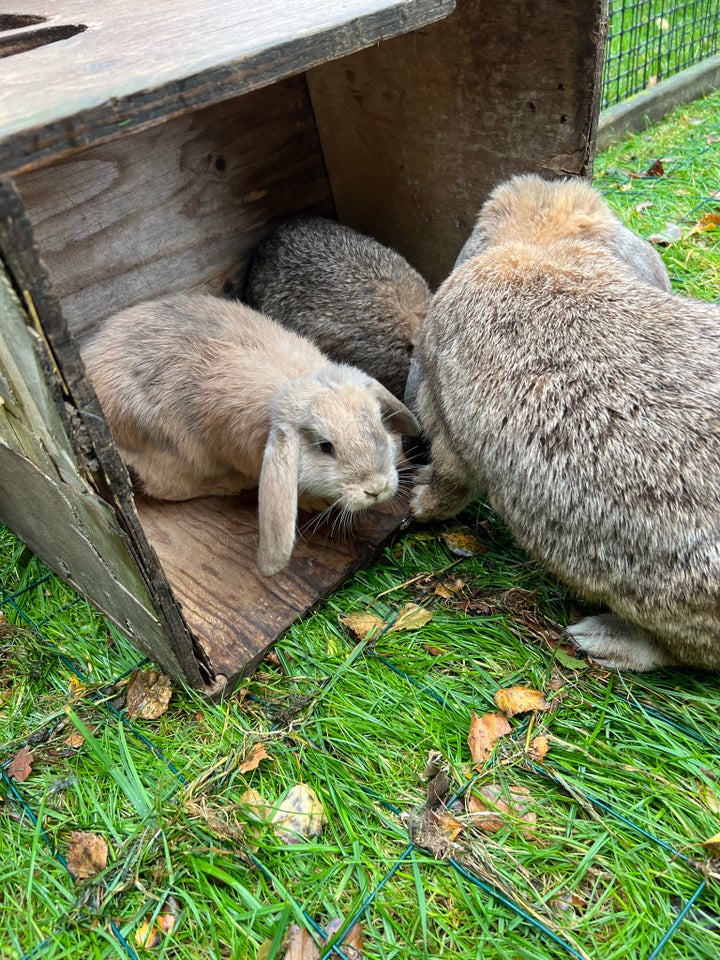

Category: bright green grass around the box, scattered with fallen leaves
[0, 94, 720, 960]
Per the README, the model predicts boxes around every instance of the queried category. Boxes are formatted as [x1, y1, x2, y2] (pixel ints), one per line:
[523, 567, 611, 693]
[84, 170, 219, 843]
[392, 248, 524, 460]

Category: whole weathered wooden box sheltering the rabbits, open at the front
[0, 0, 605, 693]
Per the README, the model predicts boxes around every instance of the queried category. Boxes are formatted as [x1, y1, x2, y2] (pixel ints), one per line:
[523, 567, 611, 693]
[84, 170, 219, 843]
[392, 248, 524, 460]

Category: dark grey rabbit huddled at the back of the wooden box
[245, 217, 430, 397]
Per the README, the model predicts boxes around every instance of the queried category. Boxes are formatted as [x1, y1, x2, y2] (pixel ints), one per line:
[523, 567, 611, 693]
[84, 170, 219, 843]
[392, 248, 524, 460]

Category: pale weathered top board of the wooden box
[0, 0, 453, 173]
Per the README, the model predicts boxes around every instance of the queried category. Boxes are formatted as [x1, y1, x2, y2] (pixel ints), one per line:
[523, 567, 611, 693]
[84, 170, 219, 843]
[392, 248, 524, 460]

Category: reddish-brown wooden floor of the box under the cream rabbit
[136, 493, 403, 688]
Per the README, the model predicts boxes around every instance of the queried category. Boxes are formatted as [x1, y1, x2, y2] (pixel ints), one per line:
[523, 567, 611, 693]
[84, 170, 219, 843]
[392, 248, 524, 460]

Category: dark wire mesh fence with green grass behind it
[602, 0, 720, 107]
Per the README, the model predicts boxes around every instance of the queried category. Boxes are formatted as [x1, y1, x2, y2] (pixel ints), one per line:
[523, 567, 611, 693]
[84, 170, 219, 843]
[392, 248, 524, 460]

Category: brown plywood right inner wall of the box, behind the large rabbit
[307, 0, 605, 284]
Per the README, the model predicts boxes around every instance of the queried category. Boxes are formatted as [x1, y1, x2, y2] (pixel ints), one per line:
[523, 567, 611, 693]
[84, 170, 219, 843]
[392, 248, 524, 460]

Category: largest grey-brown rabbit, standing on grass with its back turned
[412, 177, 720, 671]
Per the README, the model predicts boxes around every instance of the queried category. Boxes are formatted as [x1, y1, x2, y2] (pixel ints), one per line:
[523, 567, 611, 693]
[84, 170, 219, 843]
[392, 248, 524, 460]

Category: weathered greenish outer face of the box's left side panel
[0, 270, 191, 677]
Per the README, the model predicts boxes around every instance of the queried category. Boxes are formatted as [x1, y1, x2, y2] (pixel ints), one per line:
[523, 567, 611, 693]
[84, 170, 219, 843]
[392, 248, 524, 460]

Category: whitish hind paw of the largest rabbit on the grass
[566, 613, 677, 673]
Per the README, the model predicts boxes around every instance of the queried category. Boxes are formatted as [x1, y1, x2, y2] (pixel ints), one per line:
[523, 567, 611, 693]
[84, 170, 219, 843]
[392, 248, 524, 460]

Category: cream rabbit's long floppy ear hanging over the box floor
[257, 424, 300, 577]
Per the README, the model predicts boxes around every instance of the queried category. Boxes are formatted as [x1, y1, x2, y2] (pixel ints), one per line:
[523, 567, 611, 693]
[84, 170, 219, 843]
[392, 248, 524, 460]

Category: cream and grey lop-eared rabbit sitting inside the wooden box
[81, 295, 418, 576]
